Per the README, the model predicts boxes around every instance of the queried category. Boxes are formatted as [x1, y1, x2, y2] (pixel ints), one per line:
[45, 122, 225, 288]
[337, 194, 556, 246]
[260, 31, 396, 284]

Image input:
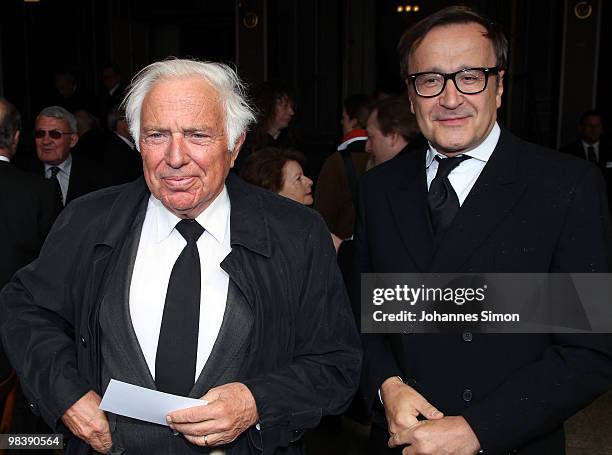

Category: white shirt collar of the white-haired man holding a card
[149, 185, 231, 245]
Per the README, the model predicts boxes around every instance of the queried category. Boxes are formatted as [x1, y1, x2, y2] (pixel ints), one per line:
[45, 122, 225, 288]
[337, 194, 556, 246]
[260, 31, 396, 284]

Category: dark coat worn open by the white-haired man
[0, 175, 361, 455]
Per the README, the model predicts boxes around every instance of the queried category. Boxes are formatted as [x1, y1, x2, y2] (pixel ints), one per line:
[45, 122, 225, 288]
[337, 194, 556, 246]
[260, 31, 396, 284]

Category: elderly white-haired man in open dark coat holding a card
[0, 60, 361, 454]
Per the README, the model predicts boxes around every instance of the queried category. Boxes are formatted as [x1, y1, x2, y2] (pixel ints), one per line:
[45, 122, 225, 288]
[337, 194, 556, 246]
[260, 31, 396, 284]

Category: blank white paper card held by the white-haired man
[100, 379, 208, 426]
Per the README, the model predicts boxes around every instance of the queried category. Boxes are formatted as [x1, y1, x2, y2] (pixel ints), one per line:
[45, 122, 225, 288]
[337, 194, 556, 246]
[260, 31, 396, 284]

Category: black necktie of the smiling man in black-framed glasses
[427, 155, 470, 238]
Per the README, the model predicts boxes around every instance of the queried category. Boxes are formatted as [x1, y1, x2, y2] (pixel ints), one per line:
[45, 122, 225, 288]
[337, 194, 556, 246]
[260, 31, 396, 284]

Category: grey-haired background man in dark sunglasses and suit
[34, 106, 112, 205]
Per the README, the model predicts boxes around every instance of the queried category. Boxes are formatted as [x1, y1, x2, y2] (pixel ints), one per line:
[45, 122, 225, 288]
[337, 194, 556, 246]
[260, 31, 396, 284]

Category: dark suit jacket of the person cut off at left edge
[0, 161, 60, 382]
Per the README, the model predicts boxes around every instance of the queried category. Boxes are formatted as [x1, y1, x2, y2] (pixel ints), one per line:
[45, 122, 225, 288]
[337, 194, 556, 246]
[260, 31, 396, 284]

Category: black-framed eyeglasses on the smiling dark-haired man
[408, 66, 499, 98]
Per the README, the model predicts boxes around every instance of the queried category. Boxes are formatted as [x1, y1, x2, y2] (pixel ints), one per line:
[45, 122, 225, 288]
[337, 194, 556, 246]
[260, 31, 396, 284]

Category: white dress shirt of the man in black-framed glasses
[425, 123, 501, 206]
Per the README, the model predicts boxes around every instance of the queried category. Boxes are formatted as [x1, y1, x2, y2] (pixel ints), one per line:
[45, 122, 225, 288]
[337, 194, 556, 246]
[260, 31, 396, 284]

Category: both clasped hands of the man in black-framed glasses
[380, 377, 480, 455]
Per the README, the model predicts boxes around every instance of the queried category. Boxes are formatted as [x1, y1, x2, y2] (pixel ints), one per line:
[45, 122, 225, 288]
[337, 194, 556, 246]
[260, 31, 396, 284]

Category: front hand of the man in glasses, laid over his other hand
[389, 416, 480, 455]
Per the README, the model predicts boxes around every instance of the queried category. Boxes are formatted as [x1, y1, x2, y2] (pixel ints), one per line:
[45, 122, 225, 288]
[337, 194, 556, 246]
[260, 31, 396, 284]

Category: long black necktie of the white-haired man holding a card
[155, 220, 204, 396]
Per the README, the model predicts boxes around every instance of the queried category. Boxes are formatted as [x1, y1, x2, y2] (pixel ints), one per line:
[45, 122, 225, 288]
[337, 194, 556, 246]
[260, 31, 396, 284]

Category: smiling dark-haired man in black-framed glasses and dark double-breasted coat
[356, 7, 612, 455]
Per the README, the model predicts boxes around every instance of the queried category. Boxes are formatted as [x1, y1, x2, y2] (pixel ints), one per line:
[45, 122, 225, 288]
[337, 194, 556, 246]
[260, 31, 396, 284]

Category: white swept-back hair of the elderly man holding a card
[122, 59, 255, 150]
